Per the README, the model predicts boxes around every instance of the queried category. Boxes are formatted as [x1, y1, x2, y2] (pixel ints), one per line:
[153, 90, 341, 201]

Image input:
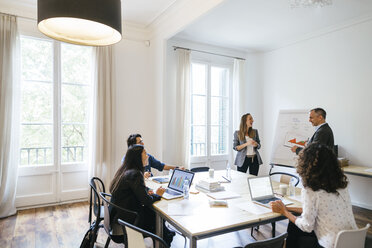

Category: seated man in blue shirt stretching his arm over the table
[121, 133, 185, 178]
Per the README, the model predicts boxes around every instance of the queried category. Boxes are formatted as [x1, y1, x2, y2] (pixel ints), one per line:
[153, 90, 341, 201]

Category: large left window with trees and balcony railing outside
[20, 36, 92, 166]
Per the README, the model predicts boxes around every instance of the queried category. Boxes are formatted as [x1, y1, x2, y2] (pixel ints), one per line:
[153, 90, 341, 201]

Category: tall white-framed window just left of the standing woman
[190, 61, 231, 167]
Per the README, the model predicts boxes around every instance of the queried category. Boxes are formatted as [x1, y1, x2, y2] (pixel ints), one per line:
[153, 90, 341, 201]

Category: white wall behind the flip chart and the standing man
[259, 17, 372, 209]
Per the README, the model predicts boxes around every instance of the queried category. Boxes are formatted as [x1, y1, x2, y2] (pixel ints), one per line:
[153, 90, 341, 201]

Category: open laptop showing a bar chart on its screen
[162, 169, 194, 200]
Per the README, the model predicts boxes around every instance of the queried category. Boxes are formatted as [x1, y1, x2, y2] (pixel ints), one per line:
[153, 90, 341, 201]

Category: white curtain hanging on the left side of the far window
[174, 49, 191, 168]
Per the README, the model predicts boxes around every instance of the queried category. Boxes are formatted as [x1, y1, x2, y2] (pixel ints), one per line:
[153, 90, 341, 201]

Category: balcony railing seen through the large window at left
[20, 146, 85, 165]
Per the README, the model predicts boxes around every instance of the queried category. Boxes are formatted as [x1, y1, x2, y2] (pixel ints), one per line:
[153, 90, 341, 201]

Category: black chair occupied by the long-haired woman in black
[99, 192, 138, 248]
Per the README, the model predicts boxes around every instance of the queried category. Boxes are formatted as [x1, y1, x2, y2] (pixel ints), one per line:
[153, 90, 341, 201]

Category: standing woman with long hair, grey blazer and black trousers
[233, 113, 262, 176]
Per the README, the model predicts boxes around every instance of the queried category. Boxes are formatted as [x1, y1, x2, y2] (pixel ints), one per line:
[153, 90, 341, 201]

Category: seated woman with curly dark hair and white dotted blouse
[270, 143, 357, 248]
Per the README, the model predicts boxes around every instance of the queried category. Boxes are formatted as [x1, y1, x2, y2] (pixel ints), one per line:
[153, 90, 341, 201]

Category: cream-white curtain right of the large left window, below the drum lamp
[90, 46, 115, 190]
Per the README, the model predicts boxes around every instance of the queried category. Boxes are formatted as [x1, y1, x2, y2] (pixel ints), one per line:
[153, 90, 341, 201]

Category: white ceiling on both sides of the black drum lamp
[0, 0, 177, 27]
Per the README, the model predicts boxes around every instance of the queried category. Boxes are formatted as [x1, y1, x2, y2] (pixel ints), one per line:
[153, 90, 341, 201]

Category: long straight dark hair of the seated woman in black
[110, 145, 145, 194]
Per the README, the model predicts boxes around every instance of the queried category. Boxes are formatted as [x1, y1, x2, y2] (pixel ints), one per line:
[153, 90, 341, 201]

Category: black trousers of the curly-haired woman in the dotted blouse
[286, 222, 322, 248]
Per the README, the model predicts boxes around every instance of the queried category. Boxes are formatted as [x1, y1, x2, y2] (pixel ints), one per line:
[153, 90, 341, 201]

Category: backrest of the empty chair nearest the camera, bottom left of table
[118, 219, 169, 248]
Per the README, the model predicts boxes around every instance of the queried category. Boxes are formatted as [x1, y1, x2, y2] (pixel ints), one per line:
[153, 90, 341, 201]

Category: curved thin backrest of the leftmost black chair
[89, 177, 106, 223]
